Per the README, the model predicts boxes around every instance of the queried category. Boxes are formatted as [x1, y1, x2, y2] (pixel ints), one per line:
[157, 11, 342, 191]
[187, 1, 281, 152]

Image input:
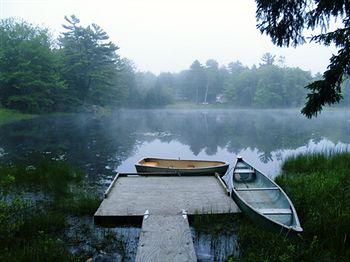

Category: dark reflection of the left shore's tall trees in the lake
[0, 114, 136, 181]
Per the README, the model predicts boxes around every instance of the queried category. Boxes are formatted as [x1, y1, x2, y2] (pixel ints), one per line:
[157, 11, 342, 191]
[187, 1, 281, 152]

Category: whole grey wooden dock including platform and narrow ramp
[94, 174, 240, 261]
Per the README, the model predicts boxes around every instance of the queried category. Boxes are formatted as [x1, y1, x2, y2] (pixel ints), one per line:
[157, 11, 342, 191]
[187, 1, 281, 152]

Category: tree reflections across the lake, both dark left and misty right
[0, 110, 350, 175]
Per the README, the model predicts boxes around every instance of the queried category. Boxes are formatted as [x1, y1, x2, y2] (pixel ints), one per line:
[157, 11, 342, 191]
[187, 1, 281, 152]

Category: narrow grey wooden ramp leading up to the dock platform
[136, 213, 197, 262]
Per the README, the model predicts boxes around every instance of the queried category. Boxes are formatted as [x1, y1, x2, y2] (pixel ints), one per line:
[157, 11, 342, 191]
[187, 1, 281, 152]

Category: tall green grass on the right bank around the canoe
[238, 153, 350, 261]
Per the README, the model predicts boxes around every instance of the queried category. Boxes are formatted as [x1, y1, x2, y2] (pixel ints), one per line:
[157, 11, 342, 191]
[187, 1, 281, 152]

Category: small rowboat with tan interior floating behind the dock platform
[135, 158, 228, 176]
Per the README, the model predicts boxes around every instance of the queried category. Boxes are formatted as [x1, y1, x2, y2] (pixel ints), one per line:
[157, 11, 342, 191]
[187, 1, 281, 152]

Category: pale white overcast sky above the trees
[0, 0, 336, 73]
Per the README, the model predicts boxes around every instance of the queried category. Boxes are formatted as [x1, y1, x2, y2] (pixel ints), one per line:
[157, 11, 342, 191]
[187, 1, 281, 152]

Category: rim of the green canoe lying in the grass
[232, 158, 303, 233]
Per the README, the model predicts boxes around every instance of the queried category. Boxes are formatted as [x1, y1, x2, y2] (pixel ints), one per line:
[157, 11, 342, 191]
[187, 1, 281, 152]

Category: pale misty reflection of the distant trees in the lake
[136, 110, 350, 161]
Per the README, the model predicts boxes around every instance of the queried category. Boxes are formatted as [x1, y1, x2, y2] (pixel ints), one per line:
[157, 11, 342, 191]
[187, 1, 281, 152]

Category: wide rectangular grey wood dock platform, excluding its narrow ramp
[95, 176, 240, 221]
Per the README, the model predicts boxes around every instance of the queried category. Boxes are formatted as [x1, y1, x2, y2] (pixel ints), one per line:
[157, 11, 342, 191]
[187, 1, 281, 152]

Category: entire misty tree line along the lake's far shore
[0, 15, 350, 113]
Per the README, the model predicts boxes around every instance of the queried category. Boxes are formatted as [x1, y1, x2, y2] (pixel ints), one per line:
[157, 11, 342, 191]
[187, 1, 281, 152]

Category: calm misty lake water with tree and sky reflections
[0, 110, 350, 258]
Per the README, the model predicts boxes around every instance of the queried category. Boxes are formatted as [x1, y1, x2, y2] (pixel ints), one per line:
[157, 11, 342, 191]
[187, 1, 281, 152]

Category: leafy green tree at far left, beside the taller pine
[0, 19, 65, 113]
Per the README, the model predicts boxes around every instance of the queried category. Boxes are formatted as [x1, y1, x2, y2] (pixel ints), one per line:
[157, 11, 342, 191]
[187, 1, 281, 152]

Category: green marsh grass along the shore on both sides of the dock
[0, 153, 350, 261]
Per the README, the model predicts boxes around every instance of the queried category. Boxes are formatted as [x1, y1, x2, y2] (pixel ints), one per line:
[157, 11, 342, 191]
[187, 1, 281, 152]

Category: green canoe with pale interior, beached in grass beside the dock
[232, 157, 303, 232]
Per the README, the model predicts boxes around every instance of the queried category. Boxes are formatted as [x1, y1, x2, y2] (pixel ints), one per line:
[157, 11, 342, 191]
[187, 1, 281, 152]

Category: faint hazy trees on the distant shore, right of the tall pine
[137, 56, 312, 108]
